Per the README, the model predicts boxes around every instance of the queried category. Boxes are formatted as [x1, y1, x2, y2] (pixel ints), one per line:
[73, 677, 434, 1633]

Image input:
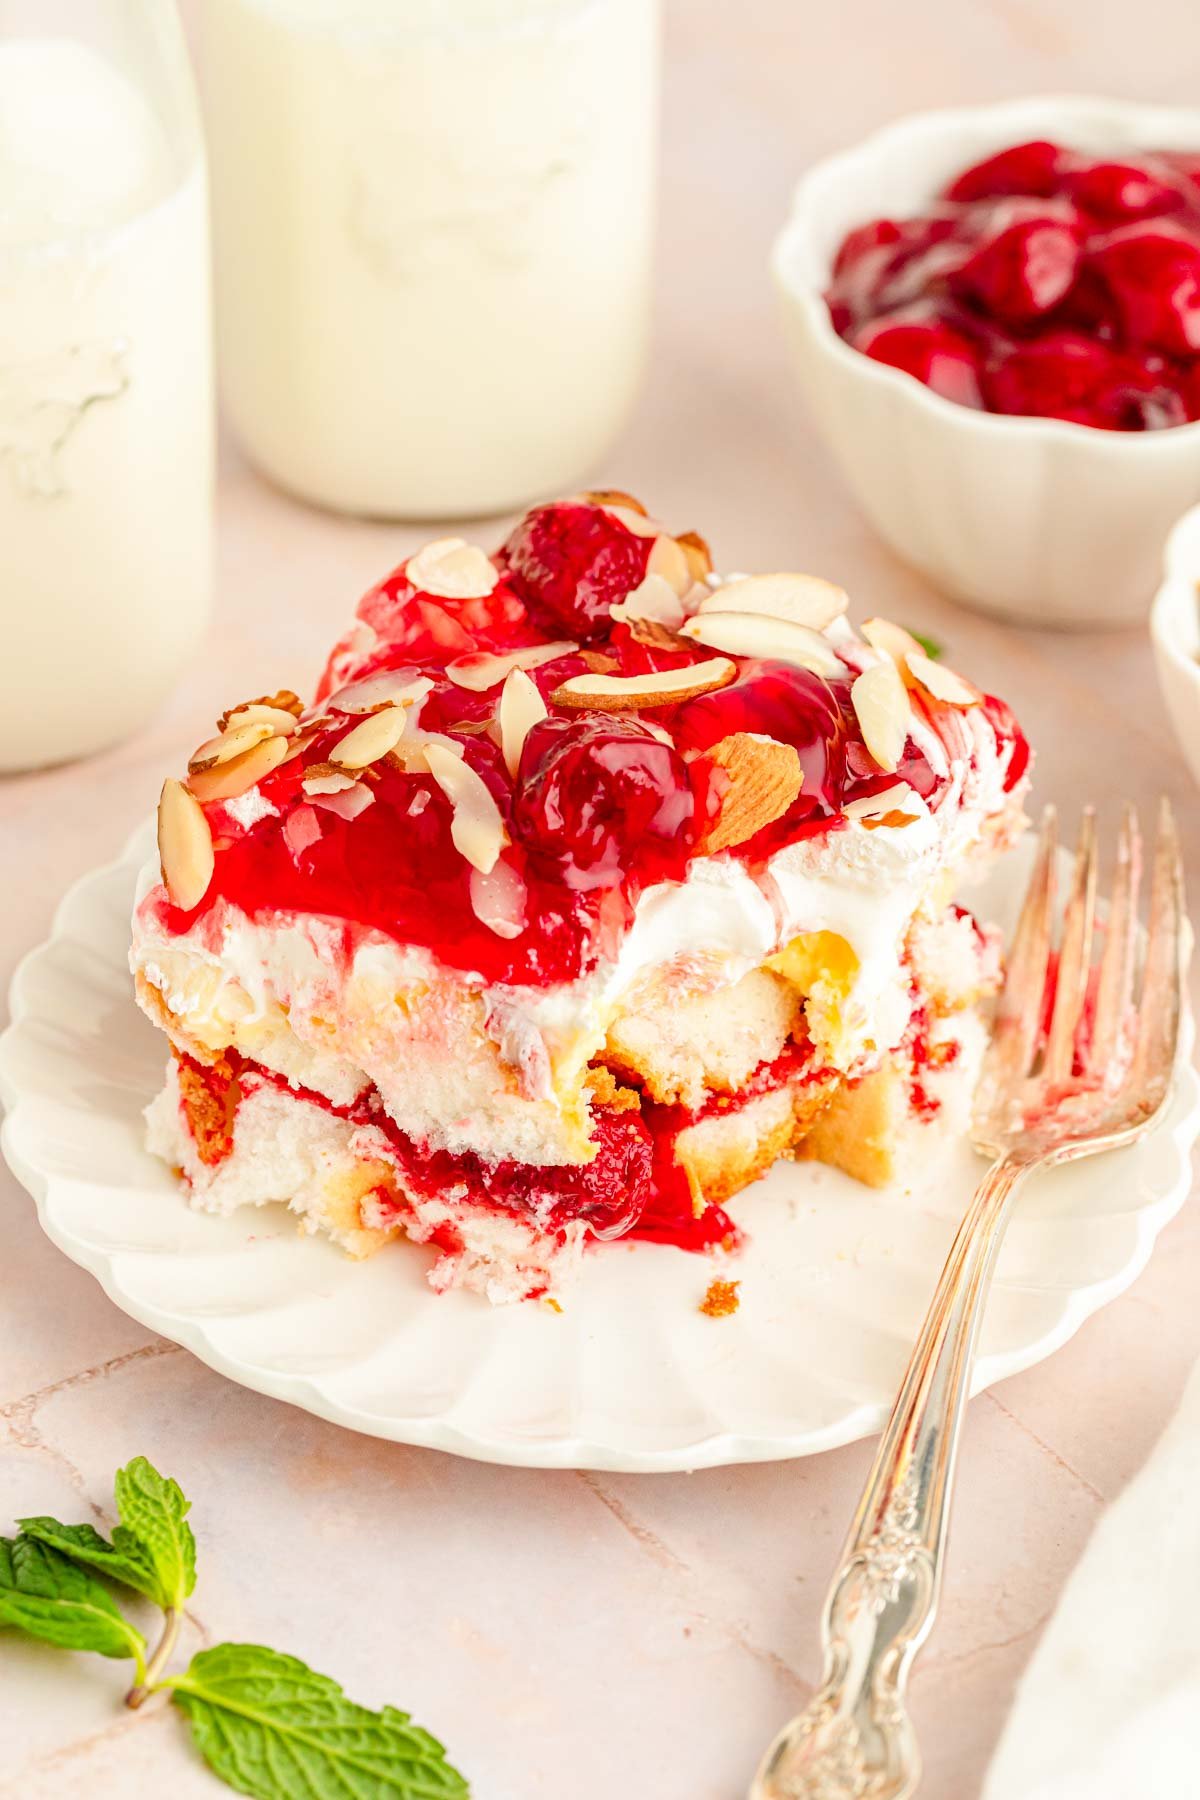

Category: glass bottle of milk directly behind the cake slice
[203, 0, 658, 517]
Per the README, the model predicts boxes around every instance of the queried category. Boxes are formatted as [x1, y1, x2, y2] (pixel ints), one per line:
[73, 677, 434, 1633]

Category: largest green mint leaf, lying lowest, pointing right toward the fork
[166, 1643, 470, 1800]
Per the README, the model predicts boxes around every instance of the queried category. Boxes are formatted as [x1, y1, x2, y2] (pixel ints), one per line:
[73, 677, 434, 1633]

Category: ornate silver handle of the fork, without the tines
[750, 1154, 1036, 1800]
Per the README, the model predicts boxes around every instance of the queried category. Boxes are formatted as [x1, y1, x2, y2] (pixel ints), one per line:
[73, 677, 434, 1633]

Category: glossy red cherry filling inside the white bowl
[828, 140, 1200, 432]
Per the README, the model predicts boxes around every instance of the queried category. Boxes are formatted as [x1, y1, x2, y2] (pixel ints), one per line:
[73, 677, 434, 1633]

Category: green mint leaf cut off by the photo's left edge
[0, 1537, 146, 1676]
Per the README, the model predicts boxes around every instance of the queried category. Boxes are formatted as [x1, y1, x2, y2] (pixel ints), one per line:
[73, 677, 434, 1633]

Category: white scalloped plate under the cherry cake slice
[0, 832, 1200, 1471]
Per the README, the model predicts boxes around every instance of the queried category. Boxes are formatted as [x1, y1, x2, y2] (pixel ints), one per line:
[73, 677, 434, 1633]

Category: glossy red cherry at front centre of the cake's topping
[513, 715, 696, 891]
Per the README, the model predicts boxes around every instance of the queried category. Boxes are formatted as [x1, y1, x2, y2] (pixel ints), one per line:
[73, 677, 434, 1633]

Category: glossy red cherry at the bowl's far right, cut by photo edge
[1088, 221, 1200, 356]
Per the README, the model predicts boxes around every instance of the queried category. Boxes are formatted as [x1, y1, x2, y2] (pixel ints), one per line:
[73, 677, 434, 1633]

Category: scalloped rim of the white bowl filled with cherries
[770, 94, 1200, 461]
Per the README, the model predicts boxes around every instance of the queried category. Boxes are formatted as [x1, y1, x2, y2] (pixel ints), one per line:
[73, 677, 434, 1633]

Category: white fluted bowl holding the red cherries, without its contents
[772, 97, 1200, 628]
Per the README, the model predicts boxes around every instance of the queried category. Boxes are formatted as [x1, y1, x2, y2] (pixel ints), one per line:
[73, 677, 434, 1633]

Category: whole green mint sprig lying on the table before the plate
[0, 1456, 470, 1800]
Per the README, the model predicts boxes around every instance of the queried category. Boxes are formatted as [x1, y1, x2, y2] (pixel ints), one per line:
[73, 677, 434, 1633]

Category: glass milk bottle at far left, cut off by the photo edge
[0, 0, 212, 770]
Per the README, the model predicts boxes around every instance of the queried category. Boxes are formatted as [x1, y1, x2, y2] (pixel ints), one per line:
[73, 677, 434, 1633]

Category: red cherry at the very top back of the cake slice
[497, 500, 653, 643]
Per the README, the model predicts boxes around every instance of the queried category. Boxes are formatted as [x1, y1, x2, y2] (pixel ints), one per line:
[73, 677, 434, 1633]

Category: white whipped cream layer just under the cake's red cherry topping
[131, 680, 1020, 1165]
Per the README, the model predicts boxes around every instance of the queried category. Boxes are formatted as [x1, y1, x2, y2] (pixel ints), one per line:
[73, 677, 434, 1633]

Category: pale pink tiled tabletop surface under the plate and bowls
[0, 0, 1200, 1800]
